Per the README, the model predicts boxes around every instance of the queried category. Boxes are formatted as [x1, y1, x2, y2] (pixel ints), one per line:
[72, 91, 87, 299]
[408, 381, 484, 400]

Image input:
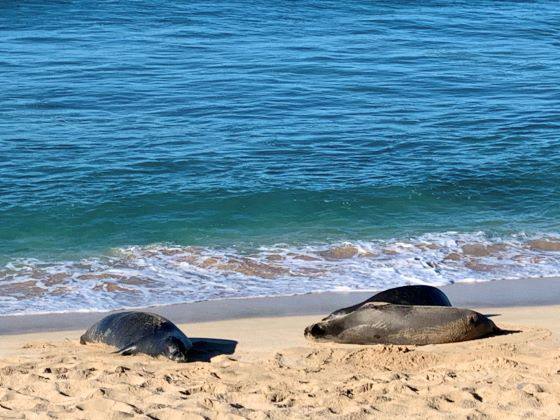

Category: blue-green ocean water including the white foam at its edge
[0, 0, 560, 314]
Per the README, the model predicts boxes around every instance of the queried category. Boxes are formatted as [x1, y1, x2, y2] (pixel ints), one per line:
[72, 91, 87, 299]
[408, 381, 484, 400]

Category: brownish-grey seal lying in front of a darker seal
[305, 302, 500, 345]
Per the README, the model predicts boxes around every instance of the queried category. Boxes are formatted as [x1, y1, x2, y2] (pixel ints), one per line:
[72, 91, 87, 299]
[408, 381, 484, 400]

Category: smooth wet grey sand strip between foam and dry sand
[0, 277, 560, 336]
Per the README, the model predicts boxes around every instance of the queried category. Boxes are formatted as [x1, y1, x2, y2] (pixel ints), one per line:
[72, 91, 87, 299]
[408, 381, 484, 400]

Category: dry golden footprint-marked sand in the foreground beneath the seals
[0, 306, 560, 419]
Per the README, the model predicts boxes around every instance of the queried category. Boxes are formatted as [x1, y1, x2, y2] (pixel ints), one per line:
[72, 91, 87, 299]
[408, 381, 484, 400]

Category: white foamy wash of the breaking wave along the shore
[0, 232, 560, 315]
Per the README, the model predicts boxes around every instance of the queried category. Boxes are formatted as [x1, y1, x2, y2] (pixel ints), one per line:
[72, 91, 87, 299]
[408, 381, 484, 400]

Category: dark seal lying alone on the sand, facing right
[80, 311, 192, 362]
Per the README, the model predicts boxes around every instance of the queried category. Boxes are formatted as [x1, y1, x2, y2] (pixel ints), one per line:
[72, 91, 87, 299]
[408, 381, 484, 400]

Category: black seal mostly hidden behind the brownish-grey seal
[323, 285, 451, 321]
